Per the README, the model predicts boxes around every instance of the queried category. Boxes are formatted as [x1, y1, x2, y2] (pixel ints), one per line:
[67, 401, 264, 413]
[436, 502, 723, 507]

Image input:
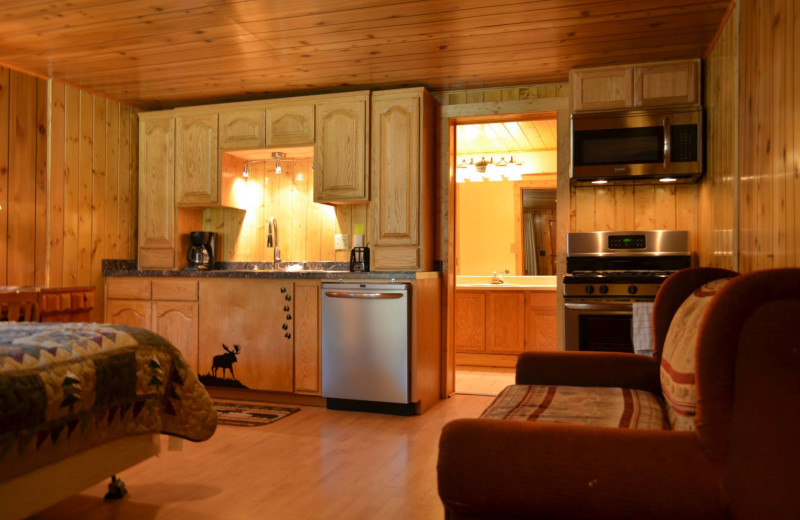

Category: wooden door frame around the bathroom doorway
[436, 96, 571, 398]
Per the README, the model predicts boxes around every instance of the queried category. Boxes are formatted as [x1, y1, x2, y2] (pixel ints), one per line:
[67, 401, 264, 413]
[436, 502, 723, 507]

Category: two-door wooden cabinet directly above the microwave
[569, 60, 700, 112]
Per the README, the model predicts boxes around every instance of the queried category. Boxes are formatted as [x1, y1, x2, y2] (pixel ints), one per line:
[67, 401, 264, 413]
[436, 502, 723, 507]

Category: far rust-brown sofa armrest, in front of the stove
[516, 352, 661, 395]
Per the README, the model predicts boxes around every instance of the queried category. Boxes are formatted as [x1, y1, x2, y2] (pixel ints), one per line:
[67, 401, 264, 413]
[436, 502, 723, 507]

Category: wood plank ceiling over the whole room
[0, 0, 732, 108]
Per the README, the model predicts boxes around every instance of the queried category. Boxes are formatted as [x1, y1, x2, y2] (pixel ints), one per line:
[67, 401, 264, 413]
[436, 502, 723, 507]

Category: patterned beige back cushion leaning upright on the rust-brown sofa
[661, 278, 731, 430]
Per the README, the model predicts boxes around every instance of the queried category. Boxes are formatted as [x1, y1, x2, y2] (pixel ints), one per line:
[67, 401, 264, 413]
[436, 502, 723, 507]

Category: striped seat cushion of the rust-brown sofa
[481, 385, 668, 430]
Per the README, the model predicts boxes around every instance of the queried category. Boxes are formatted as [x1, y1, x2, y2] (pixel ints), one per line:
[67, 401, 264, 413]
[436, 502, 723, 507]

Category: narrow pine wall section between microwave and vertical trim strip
[698, 6, 739, 270]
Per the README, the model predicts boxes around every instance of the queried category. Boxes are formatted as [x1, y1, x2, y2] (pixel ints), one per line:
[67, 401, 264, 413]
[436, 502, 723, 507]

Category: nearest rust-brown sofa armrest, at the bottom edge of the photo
[438, 419, 726, 520]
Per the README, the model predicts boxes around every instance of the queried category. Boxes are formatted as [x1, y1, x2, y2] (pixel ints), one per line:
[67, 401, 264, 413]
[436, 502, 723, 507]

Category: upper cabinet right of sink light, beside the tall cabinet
[314, 92, 369, 203]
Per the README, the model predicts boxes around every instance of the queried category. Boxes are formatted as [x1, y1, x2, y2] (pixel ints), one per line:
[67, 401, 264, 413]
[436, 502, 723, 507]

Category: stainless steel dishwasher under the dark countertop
[321, 283, 414, 415]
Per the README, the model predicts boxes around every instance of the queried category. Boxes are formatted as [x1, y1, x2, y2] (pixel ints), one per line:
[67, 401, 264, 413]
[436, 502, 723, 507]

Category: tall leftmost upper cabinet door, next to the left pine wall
[139, 117, 176, 269]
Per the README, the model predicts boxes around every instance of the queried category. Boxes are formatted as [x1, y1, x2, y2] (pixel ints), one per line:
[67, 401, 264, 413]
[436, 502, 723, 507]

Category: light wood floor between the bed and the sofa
[31, 395, 491, 520]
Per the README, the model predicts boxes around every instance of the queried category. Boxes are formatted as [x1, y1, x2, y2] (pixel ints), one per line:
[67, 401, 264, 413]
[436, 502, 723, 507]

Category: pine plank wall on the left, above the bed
[0, 67, 138, 320]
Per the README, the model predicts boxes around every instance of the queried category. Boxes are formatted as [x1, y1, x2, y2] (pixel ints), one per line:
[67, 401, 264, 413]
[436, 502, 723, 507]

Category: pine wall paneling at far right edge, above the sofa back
[736, 0, 800, 272]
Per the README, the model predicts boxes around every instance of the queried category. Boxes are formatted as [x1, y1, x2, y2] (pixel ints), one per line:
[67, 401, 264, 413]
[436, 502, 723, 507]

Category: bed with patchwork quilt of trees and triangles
[0, 322, 217, 518]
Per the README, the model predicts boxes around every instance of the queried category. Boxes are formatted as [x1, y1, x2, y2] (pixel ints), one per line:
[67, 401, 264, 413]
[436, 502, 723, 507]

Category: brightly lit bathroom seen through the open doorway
[453, 112, 558, 395]
